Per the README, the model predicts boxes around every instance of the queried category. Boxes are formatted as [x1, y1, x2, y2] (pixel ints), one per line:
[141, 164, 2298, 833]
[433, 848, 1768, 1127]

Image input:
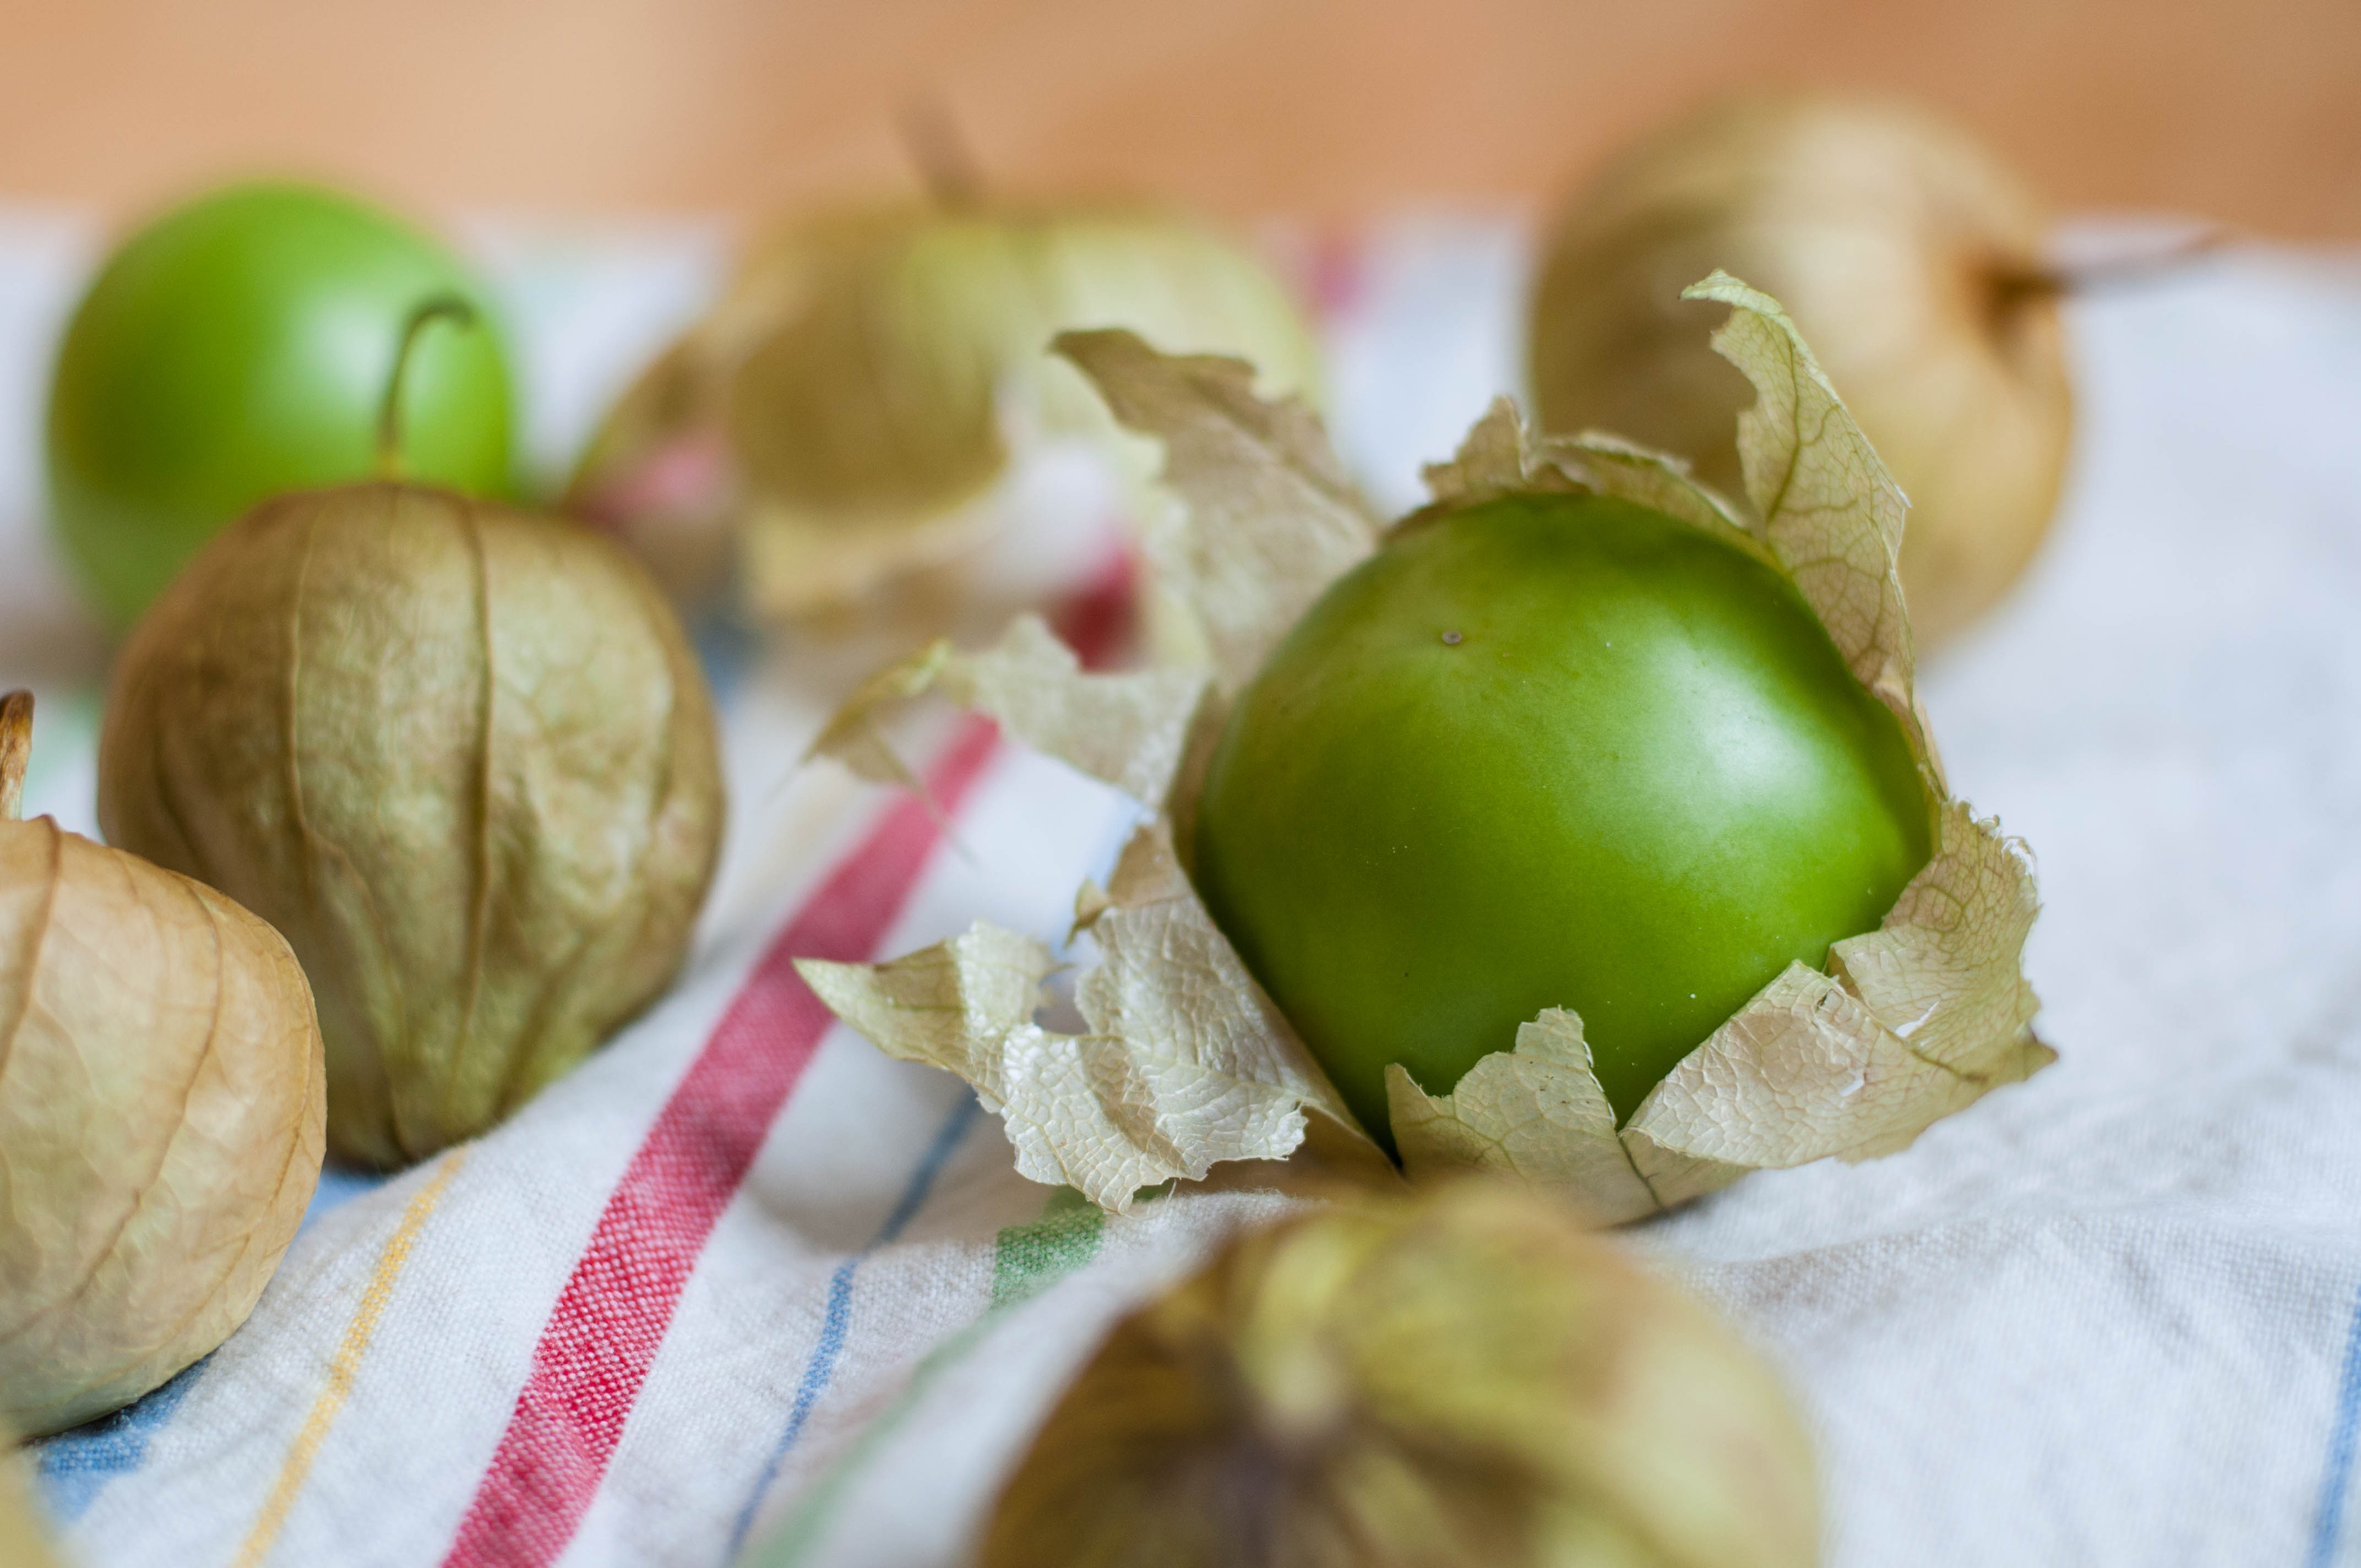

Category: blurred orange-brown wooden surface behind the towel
[0, 0, 2361, 238]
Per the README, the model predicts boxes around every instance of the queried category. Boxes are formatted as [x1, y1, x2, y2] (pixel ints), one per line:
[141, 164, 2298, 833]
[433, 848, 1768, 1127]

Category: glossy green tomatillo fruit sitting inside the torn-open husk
[1195, 496, 1932, 1138]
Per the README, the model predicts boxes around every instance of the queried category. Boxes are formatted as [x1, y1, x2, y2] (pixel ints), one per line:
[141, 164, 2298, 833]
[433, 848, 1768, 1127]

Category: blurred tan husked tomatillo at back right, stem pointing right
[1530, 95, 2073, 643]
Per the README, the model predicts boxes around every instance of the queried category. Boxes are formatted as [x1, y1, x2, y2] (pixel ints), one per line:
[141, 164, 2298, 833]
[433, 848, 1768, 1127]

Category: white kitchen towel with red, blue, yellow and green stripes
[14, 220, 2361, 1568]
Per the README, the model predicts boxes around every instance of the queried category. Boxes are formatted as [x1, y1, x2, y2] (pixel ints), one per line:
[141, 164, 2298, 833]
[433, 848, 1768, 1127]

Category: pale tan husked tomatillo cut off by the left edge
[0, 692, 326, 1434]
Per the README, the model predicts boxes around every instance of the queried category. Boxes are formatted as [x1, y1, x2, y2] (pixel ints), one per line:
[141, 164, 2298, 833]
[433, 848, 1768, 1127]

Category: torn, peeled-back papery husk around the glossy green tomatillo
[814, 274, 2052, 1221]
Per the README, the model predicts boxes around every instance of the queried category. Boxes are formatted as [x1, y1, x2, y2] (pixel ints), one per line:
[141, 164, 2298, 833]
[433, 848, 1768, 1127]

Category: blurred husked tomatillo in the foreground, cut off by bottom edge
[982, 1183, 1818, 1568]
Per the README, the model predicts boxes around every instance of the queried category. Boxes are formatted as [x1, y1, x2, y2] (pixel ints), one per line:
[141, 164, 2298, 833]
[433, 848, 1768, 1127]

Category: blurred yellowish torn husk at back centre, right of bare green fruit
[569, 205, 1318, 619]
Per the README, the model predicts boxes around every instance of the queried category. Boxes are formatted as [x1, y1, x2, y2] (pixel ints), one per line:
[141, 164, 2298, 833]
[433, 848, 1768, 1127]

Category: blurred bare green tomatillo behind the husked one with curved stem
[47, 184, 510, 626]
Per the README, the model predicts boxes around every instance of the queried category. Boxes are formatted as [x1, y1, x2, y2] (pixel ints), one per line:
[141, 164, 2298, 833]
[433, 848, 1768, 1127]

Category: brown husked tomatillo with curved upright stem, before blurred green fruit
[99, 484, 722, 1167]
